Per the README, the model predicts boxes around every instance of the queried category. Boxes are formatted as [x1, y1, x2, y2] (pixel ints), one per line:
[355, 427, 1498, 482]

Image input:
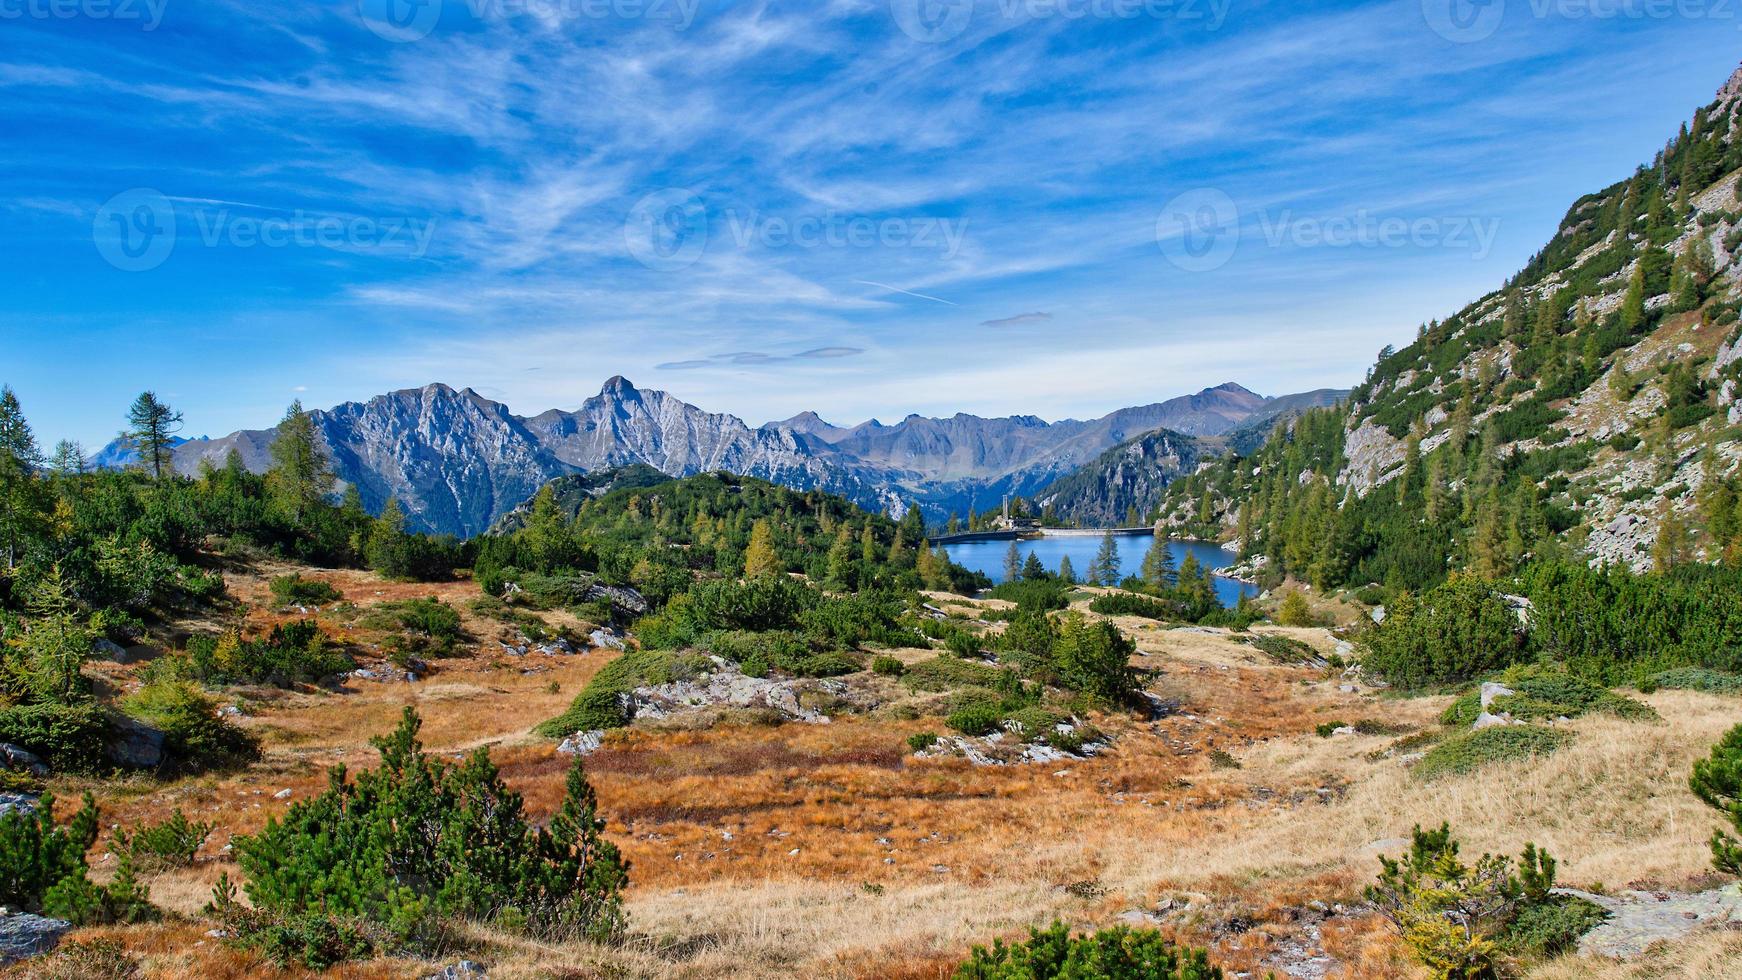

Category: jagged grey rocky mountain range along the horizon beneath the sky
[99, 376, 1344, 536]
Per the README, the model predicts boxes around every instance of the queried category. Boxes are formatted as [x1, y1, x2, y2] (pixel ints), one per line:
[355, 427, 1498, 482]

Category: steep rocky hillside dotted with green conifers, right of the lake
[1158, 67, 1742, 588]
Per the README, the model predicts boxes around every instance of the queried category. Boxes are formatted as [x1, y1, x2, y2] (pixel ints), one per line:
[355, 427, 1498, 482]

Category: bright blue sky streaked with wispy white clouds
[0, 0, 1742, 447]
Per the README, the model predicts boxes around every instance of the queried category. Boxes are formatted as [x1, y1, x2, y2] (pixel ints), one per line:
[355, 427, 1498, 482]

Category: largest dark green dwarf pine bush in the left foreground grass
[211, 707, 627, 966]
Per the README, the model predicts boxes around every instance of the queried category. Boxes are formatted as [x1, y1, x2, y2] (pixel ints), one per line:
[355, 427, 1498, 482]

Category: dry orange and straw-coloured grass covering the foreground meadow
[30, 573, 1742, 980]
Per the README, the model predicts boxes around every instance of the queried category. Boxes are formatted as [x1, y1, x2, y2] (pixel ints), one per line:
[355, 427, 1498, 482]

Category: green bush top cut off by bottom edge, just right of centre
[955, 923, 1223, 980]
